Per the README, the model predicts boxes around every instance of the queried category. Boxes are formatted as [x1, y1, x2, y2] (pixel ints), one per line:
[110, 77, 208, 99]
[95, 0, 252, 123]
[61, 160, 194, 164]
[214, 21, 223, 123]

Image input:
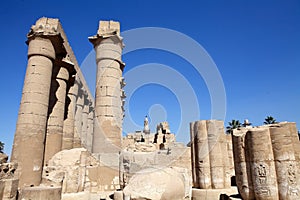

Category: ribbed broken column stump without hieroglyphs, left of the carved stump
[190, 120, 232, 189]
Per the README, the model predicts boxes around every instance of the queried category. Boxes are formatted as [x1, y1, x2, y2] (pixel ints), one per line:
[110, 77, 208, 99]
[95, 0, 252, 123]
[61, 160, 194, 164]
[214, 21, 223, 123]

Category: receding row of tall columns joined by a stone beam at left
[11, 18, 94, 188]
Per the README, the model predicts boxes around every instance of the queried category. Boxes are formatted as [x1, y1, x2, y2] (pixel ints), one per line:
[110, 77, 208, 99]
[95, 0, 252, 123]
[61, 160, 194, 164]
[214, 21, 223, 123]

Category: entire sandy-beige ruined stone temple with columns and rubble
[0, 17, 300, 200]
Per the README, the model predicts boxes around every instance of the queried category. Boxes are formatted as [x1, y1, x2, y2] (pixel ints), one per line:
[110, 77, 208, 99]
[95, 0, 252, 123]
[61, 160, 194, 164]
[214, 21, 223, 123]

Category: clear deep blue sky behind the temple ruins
[0, 0, 300, 154]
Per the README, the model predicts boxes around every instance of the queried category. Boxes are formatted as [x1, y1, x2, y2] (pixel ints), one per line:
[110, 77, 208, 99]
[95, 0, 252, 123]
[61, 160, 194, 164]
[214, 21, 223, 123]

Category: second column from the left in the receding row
[44, 66, 69, 164]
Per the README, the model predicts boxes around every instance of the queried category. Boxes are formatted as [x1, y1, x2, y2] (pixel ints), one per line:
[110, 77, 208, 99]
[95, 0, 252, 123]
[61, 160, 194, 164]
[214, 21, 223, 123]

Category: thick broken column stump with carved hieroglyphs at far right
[232, 122, 300, 200]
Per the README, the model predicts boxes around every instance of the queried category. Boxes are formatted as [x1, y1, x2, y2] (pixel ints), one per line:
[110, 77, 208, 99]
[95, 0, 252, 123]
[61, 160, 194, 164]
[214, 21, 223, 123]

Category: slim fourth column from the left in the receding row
[73, 83, 84, 148]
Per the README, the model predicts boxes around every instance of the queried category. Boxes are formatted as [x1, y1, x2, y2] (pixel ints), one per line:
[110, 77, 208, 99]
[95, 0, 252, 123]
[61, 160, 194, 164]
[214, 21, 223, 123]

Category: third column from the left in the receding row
[62, 77, 78, 149]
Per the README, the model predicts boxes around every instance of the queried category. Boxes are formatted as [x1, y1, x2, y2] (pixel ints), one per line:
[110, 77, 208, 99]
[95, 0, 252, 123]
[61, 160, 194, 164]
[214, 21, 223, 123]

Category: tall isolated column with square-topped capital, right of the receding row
[89, 21, 124, 153]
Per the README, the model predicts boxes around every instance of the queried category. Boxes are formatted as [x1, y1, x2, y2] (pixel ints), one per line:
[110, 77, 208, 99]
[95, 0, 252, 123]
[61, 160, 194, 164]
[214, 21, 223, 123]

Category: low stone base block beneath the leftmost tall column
[18, 186, 61, 200]
